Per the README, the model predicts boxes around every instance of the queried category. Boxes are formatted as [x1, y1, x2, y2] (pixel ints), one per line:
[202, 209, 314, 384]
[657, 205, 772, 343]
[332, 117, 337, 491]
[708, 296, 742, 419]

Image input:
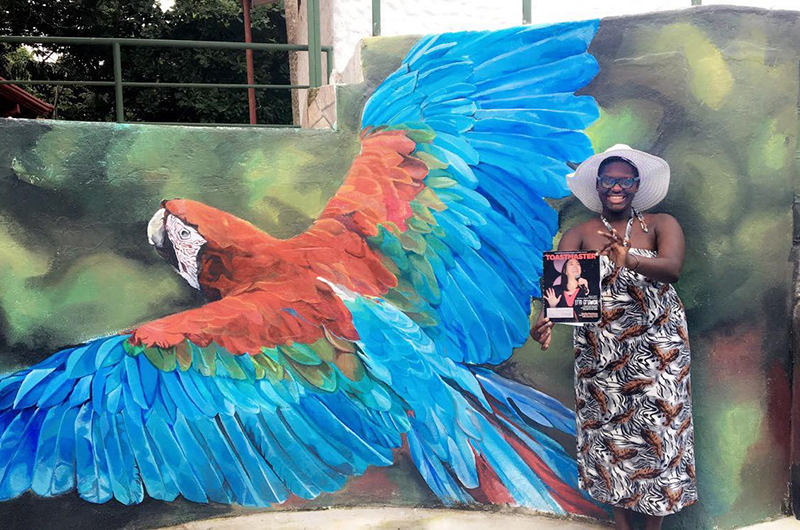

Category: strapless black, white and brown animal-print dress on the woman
[574, 249, 697, 515]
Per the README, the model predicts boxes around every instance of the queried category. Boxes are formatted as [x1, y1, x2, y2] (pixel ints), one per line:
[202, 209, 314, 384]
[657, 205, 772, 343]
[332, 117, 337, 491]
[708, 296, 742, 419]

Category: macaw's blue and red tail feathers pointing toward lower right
[345, 288, 604, 517]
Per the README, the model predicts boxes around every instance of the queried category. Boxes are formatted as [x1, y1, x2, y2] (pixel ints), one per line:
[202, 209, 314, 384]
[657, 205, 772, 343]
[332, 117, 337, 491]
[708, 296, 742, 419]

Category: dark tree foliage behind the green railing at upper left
[0, 0, 291, 123]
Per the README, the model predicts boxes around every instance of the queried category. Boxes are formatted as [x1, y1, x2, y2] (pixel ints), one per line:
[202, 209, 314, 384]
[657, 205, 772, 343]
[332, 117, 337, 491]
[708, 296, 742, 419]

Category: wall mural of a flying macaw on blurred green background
[0, 4, 800, 529]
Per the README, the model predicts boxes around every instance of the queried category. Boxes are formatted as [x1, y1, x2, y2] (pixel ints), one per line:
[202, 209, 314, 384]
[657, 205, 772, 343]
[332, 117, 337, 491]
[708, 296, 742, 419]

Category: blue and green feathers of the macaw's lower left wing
[0, 326, 408, 506]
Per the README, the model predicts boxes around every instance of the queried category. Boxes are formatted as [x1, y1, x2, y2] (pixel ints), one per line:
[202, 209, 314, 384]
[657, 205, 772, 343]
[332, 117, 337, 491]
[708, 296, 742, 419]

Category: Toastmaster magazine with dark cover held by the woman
[542, 251, 601, 325]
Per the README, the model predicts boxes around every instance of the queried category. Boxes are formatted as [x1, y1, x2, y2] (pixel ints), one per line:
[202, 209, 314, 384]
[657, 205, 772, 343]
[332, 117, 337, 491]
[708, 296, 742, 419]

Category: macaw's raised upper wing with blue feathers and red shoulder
[316, 21, 598, 363]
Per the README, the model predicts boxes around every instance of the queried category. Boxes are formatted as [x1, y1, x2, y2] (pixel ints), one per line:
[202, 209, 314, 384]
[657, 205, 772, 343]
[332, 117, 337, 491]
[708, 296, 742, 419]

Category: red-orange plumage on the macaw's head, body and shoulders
[130, 131, 428, 354]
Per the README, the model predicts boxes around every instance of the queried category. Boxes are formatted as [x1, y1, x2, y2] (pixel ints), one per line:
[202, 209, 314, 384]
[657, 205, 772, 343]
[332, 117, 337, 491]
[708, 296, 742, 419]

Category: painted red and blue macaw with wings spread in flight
[0, 21, 605, 517]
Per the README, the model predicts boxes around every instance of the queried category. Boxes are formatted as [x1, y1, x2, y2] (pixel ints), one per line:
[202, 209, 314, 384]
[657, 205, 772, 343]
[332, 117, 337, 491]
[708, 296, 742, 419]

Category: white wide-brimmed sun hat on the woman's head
[567, 144, 669, 212]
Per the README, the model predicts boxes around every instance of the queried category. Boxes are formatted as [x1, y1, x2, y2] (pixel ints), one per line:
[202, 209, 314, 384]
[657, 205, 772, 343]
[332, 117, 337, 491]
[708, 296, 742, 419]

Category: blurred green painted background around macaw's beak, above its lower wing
[0, 115, 359, 371]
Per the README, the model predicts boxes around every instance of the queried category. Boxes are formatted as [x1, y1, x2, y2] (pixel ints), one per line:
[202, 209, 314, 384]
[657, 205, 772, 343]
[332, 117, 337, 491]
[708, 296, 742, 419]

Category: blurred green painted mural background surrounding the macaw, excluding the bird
[0, 8, 800, 529]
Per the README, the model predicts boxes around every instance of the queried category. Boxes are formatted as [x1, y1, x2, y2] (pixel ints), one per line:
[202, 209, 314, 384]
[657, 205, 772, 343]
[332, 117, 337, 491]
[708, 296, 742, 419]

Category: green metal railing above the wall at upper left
[0, 0, 333, 127]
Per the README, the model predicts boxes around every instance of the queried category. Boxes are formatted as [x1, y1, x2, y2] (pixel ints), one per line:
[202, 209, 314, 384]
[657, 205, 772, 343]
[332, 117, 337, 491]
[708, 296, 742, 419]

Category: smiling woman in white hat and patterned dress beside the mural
[531, 145, 697, 530]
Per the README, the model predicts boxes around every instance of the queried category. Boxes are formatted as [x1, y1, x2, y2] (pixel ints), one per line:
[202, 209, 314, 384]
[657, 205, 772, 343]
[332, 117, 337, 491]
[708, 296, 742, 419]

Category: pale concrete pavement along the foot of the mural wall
[156, 508, 800, 530]
